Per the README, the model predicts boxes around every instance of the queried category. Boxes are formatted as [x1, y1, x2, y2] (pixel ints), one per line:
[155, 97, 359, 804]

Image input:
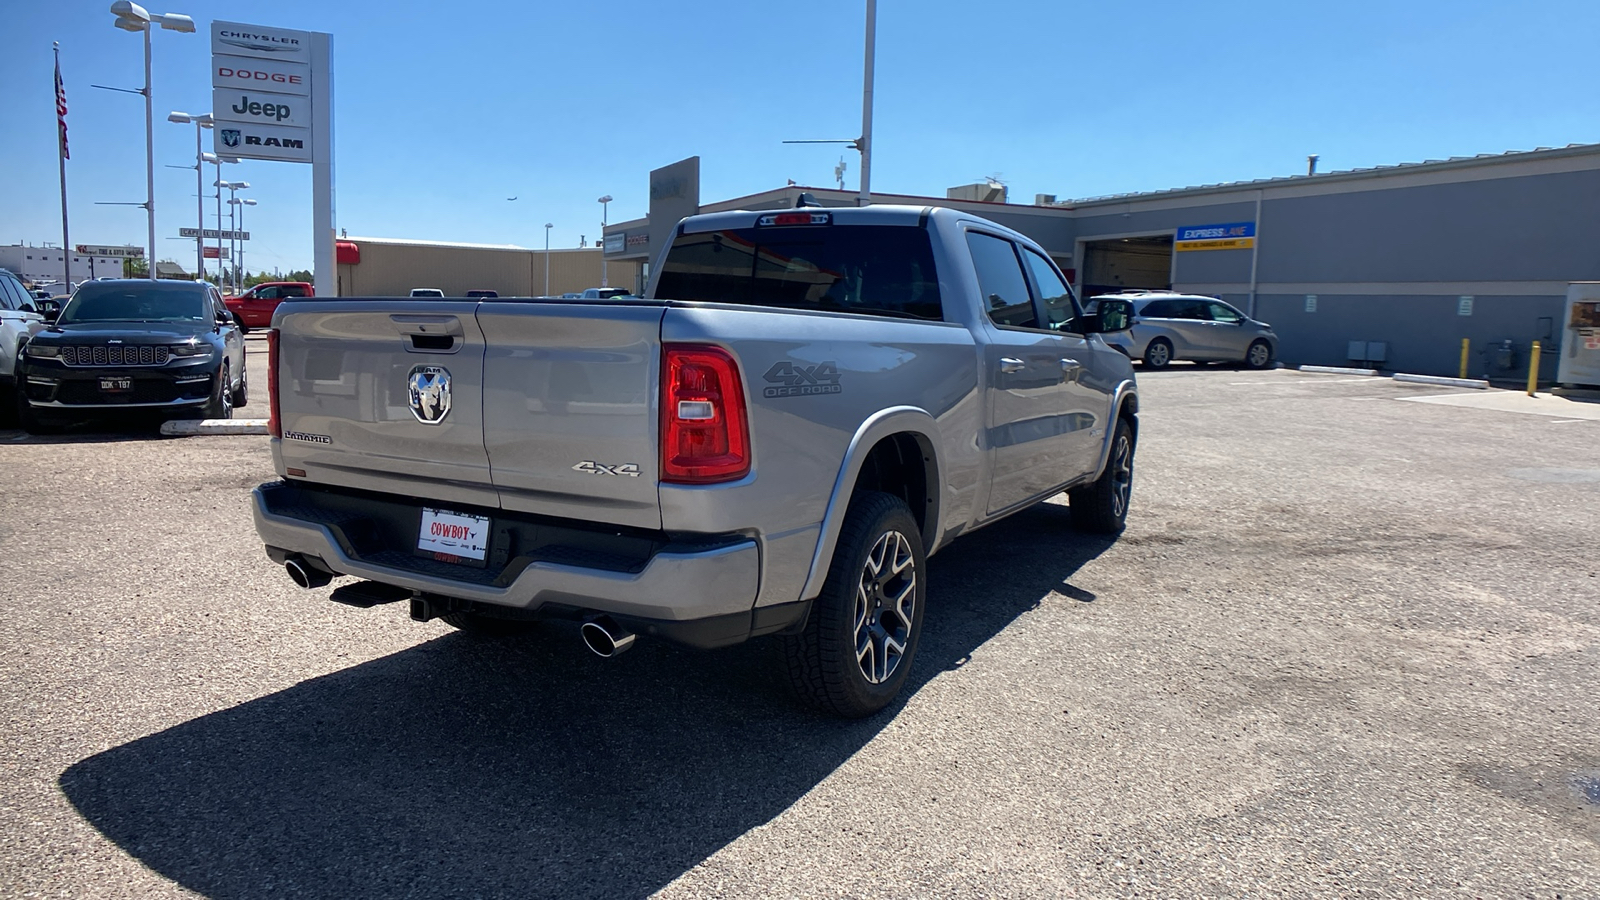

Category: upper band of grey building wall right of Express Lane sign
[1260, 171, 1600, 282]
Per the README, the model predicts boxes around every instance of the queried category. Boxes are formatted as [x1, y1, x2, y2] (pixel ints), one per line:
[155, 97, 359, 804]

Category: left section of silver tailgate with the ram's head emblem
[277, 299, 499, 506]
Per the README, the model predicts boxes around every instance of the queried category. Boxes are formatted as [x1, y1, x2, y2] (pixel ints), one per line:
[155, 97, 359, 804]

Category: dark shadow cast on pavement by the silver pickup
[59, 504, 1112, 897]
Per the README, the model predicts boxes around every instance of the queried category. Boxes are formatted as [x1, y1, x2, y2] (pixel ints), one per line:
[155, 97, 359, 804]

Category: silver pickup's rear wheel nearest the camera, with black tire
[779, 492, 928, 719]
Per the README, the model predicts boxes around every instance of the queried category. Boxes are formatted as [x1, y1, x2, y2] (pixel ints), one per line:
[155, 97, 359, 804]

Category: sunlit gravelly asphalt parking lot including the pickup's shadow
[0, 365, 1600, 897]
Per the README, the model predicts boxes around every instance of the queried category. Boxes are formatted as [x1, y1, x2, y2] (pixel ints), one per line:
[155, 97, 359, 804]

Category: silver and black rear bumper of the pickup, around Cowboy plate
[251, 482, 760, 645]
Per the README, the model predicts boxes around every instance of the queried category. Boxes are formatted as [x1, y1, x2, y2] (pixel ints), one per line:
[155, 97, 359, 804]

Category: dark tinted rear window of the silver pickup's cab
[656, 224, 940, 322]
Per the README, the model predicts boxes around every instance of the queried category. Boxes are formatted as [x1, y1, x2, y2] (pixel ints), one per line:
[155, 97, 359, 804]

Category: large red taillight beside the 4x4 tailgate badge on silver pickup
[661, 344, 750, 484]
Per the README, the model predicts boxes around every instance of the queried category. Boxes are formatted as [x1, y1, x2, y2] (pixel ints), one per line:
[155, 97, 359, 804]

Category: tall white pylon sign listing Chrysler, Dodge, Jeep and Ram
[211, 22, 338, 296]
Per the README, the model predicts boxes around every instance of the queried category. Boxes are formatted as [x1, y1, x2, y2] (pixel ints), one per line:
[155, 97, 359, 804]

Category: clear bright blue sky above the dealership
[0, 0, 1600, 269]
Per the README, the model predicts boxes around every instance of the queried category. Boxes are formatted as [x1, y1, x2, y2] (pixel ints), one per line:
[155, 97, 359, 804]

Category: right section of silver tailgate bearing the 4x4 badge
[477, 301, 666, 528]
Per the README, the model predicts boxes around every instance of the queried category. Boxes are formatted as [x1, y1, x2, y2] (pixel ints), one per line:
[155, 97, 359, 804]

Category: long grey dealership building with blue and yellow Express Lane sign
[603, 144, 1600, 380]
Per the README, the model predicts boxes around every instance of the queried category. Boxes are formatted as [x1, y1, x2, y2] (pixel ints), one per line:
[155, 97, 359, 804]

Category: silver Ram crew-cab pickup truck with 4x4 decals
[254, 207, 1138, 716]
